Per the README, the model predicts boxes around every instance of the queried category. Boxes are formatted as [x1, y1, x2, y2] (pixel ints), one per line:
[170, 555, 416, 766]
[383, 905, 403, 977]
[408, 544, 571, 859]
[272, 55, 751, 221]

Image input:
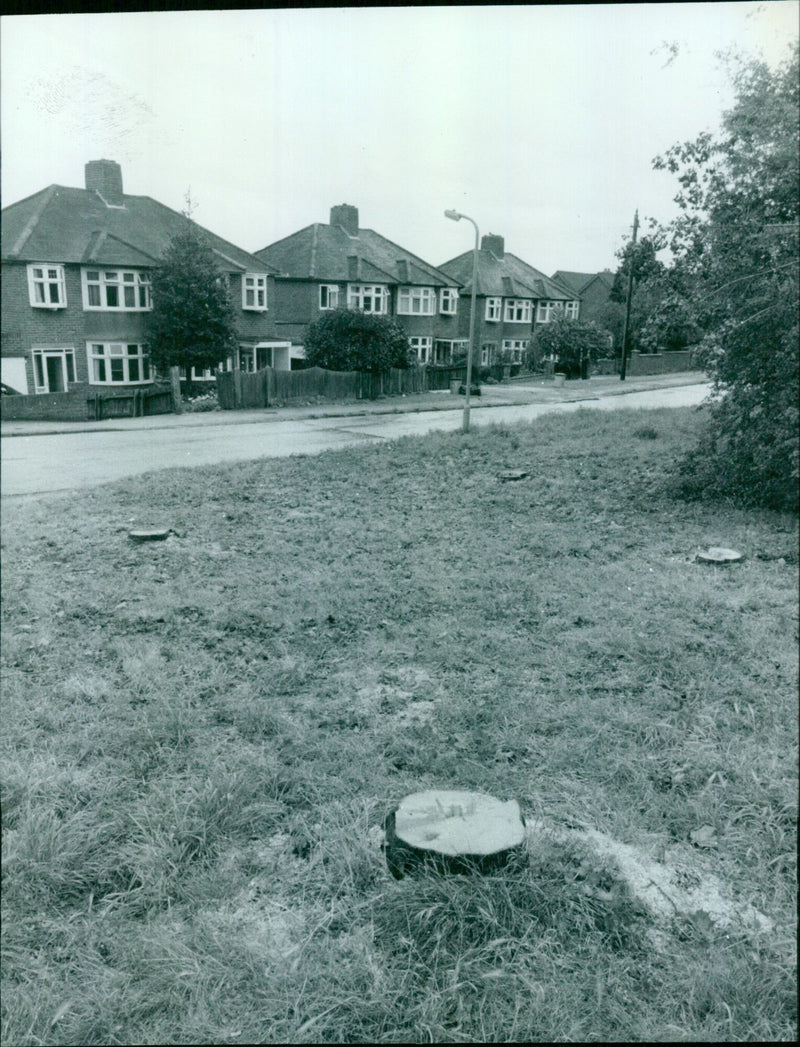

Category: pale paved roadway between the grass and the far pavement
[0, 383, 710, 497]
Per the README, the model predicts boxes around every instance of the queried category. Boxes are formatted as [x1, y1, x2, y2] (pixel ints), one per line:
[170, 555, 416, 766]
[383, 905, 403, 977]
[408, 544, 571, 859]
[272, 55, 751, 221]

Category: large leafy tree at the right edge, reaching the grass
[651, 45, 800, 510]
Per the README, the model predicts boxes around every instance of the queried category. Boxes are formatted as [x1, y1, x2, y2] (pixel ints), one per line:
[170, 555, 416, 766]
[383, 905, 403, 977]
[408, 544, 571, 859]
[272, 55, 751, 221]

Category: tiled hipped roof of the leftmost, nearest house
[2, 185, 273, 273]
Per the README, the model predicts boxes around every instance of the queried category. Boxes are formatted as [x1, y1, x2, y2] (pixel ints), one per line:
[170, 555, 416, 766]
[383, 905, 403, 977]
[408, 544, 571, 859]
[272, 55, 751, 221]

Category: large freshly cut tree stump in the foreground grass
[384, 789, 525, 879]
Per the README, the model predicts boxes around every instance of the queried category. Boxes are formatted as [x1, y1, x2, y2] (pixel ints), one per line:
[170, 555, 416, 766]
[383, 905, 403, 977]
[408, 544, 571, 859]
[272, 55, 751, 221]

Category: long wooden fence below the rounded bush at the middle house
[217, 365, 466, 410]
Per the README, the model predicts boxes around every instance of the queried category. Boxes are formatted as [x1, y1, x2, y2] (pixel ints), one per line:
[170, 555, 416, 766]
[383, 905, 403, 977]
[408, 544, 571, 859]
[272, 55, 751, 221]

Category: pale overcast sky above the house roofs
[0, 0, 800, 274]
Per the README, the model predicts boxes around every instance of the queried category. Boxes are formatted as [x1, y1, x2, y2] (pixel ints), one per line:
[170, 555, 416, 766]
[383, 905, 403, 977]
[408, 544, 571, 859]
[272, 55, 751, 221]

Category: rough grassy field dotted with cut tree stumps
[2, 410, 798, 1045]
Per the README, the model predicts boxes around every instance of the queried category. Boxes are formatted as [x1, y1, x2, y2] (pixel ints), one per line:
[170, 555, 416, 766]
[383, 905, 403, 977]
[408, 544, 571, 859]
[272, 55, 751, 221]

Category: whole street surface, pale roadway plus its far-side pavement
[0, 375, 710, 497]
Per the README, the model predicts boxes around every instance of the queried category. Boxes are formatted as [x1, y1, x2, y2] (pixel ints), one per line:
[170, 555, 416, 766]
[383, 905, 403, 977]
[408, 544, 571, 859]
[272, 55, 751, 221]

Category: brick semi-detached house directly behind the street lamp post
[439, 233, 579, 366]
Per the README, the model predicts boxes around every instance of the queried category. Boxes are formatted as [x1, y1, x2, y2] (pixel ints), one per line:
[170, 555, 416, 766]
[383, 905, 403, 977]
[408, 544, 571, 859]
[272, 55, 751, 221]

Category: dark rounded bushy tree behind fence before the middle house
[305, 309, 409, 374]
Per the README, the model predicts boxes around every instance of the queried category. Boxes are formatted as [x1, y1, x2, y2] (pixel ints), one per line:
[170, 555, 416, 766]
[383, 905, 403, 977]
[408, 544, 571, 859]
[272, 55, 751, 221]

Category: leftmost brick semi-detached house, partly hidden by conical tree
[0, 160, 289, 417]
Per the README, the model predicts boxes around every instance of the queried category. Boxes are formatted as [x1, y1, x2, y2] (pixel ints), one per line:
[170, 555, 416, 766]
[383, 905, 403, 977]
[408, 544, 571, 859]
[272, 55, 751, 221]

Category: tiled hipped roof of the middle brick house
[255, 222, 458, 287]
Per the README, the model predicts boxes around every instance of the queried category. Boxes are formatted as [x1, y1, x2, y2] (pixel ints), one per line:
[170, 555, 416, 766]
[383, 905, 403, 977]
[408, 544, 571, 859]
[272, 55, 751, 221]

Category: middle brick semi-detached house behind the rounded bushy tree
[255, 204, 466, 363]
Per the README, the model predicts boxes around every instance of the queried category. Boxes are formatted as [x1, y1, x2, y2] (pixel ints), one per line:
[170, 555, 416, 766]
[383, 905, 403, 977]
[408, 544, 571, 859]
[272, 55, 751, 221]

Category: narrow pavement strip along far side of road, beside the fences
[0, 371, 708, 438]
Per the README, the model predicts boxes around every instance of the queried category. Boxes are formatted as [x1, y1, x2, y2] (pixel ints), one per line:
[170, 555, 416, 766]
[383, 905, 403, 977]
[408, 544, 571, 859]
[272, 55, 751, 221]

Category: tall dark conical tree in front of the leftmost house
[149, 220, 237, 370]
